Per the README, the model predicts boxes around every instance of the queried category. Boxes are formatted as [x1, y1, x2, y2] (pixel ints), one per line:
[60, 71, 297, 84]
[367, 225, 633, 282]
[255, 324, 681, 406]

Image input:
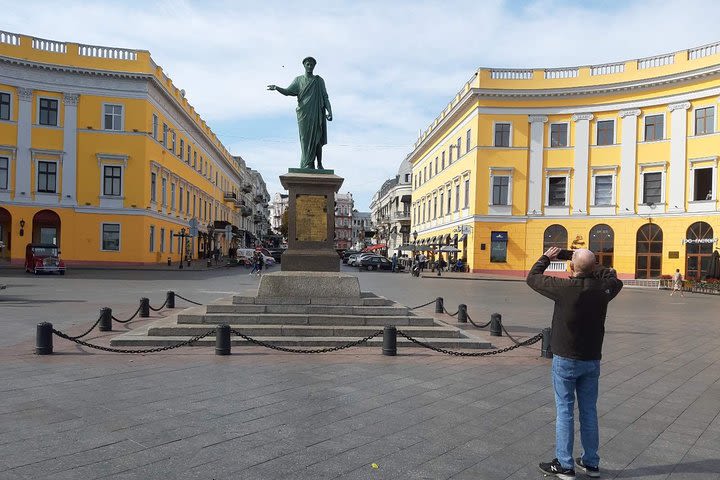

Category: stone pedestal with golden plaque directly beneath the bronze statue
[280, 169, 344, 272]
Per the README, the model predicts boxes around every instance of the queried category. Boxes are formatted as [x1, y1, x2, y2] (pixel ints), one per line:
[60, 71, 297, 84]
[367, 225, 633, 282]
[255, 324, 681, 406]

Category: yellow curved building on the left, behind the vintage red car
[0, 32, 268, 266]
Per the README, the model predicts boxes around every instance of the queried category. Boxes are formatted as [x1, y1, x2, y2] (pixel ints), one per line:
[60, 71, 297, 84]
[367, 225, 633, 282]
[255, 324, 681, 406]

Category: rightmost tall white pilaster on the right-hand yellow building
[663, 102, 690, 212]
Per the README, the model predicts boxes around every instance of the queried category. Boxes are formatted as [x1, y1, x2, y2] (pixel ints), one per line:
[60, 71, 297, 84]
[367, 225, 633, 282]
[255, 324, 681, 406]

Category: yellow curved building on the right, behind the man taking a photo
[410, 43, 720, 278]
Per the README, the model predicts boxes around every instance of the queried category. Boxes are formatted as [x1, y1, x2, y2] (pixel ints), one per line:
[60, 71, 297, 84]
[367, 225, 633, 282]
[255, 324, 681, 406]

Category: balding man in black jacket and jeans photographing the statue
[527, 247, 622, 480]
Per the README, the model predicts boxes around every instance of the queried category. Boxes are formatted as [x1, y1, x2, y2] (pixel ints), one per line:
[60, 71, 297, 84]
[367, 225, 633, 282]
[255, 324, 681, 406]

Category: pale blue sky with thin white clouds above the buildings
[5, 0, 720, 211]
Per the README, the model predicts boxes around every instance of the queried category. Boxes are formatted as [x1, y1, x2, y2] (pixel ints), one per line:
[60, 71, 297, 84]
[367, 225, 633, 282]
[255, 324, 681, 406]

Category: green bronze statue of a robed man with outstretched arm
[268, 57, 332, 169]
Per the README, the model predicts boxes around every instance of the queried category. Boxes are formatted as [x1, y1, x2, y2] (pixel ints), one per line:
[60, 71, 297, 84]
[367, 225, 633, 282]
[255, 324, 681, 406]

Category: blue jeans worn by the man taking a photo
[552, 355, 600, 468]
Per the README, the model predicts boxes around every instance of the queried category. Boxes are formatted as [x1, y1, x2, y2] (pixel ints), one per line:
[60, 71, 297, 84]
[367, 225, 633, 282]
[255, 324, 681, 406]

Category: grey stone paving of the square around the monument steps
[0, 269, 720, 479]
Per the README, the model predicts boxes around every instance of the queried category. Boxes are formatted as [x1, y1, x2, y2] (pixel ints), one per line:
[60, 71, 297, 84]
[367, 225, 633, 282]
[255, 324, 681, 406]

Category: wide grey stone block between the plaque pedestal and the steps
[257, 272, 360, 299]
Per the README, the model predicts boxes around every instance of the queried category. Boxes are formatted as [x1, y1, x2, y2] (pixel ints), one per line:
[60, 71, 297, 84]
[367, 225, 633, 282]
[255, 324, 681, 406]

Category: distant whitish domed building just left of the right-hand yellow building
[370, 156, 412, 255]
